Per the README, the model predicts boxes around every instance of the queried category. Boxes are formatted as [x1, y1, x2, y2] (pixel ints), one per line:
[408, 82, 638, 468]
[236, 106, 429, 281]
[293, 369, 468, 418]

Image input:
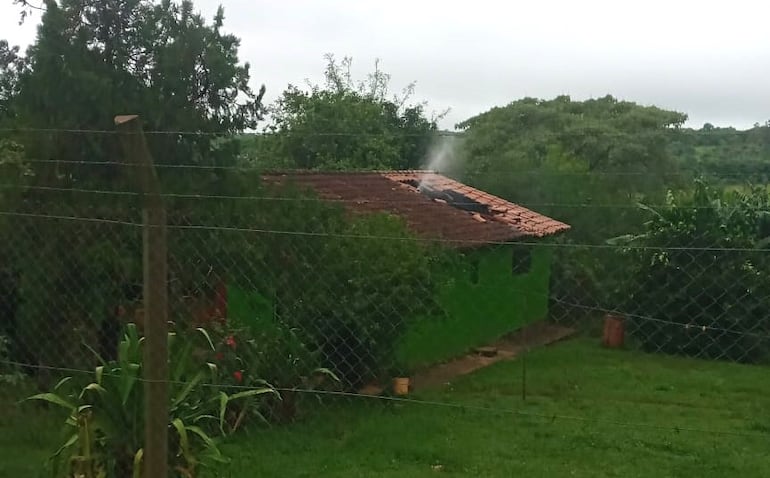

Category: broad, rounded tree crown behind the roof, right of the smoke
[455, 96, 687, 239]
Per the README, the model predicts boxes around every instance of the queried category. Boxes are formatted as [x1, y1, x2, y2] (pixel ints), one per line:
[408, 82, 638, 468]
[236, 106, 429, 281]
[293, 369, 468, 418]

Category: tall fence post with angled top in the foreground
[115, 115, 169, 478]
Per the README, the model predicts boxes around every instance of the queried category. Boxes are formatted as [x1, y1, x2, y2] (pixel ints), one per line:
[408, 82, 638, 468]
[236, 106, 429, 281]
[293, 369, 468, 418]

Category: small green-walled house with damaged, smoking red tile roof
[240, 171, 569, 366]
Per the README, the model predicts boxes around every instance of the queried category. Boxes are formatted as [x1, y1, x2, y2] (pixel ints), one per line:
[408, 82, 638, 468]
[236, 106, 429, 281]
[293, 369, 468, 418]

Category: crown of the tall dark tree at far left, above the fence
[0, 0, 264, 182]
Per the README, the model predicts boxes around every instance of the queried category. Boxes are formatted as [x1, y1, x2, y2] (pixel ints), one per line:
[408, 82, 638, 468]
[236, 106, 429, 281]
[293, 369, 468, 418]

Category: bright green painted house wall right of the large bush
[397, 246, 551, 367]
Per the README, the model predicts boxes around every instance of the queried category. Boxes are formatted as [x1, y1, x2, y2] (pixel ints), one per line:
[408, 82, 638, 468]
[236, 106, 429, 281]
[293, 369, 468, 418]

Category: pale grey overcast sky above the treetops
[0, 0, 770, 128]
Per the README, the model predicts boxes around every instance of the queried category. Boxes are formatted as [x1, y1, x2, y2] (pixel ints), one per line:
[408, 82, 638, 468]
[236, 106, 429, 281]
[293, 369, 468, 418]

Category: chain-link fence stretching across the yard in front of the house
[0, 130, 770, 476]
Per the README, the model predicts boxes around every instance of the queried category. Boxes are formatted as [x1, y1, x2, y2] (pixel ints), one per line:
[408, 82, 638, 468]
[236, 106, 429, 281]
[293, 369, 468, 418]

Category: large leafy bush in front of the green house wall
[164, 180, 436, 388]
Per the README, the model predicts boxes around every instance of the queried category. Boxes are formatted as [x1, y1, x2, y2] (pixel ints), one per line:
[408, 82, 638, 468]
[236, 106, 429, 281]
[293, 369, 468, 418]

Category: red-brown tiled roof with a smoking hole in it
[264, 171, 569, 247]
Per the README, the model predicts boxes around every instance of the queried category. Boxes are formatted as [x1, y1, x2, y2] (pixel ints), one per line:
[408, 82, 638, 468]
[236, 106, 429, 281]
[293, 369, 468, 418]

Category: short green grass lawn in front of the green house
[6, 339, 770, 478]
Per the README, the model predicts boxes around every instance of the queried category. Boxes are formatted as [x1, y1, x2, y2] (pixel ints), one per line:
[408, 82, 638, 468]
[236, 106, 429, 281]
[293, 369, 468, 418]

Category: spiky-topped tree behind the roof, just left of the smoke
[255, 55, 437, 170]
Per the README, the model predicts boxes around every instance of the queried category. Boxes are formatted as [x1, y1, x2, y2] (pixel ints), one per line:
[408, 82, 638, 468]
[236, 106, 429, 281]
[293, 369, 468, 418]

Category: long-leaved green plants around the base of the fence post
[29, 324, 275, 478]
